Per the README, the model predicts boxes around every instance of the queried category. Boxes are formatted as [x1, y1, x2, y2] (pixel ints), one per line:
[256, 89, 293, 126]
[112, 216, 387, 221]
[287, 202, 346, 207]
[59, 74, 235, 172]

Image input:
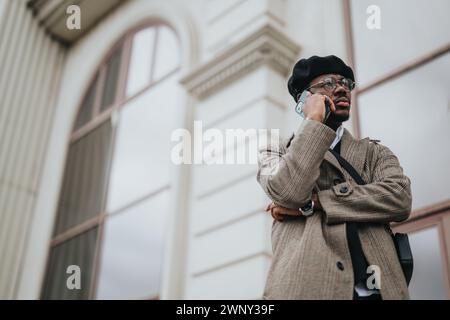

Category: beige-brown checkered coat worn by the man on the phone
[257, 120, 411, 299]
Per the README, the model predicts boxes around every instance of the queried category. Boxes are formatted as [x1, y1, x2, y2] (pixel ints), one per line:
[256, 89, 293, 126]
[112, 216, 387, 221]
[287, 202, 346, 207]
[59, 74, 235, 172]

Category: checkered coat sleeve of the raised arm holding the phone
[257, 120, 336, 208]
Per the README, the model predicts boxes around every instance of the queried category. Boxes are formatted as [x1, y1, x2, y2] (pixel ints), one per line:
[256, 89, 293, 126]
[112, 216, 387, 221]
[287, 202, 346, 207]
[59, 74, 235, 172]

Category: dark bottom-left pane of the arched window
[42, 228, 97, 300]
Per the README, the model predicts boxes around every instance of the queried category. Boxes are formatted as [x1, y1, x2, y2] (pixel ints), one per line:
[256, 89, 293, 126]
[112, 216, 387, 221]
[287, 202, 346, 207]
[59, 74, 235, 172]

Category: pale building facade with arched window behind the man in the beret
[0, 0, 450, 299]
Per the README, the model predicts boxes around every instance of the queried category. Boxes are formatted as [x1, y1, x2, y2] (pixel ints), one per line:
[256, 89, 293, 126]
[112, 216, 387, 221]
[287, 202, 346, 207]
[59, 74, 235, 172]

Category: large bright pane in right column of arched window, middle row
[107, 74, 179, 212]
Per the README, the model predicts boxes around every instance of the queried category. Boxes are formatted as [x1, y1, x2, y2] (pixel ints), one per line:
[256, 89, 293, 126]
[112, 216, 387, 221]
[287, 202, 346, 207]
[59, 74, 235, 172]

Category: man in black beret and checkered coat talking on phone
[257, 56, 411, 300]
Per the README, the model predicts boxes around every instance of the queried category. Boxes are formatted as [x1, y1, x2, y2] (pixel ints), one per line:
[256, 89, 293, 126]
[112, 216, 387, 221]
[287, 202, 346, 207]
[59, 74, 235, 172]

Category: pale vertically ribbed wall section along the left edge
[0, 0, 65, 299]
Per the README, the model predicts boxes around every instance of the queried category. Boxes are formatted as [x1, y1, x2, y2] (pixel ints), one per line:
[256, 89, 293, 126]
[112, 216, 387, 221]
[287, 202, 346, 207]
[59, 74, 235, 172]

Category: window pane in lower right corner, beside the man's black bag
[409, 227, 448, 300]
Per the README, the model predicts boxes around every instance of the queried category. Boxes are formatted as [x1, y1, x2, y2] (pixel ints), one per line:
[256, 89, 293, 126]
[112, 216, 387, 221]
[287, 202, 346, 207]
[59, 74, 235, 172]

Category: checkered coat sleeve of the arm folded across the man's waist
[318, 144, 412, 224]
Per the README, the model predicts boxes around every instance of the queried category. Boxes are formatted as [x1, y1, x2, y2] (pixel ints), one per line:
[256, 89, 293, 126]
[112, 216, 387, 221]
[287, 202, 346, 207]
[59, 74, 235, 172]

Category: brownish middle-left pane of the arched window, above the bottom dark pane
[55, 121, 111, 234]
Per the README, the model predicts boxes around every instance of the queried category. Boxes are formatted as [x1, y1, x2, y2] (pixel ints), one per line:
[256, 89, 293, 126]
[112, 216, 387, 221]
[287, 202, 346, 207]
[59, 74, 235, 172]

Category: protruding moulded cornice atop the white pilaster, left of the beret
[180, 25, 300, 100]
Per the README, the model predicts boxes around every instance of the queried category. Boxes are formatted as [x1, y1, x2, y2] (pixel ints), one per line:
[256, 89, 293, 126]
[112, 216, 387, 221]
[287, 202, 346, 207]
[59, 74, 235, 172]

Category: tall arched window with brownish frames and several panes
[42, 24, 180, 299]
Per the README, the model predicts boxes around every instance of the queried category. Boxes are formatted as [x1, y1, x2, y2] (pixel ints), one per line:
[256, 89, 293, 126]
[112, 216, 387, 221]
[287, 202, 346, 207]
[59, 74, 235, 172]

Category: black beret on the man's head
[288, 55, 355, 101]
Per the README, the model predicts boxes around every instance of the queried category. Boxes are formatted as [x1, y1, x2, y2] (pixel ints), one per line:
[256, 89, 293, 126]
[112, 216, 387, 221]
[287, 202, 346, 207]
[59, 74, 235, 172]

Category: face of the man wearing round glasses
[309, 74, 352, 122]
